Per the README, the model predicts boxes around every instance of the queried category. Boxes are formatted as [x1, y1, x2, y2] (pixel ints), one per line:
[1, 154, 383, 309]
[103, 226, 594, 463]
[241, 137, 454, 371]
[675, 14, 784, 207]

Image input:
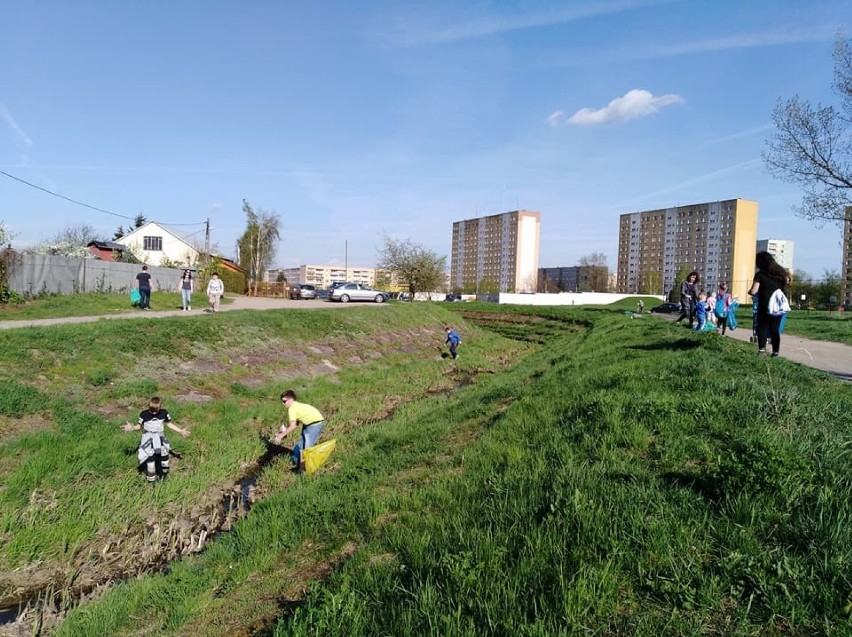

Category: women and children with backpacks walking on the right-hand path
[677, 251, 790, 356]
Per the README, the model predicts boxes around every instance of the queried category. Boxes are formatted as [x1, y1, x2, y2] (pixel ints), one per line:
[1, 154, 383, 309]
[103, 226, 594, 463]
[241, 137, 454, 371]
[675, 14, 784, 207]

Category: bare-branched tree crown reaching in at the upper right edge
[763, 31, 852, 226]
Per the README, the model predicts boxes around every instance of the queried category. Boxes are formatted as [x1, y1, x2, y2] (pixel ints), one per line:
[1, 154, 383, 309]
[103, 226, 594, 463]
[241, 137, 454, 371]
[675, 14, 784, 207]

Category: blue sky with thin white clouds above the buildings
[0, 0, 852, 276]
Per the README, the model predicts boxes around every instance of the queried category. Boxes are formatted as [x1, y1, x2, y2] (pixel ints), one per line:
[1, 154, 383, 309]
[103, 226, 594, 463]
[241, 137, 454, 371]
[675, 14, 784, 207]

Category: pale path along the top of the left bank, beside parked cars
[0, 295, 384, 330]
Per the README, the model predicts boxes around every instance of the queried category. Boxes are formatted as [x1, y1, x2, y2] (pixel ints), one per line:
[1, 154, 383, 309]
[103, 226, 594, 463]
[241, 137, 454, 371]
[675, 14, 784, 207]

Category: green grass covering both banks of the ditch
[0, 304, 852, 637]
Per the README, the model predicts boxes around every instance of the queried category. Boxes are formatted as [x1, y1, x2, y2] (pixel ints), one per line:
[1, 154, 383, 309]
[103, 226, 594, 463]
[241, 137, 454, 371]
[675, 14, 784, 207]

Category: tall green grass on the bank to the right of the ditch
[36, 309, 852, 636]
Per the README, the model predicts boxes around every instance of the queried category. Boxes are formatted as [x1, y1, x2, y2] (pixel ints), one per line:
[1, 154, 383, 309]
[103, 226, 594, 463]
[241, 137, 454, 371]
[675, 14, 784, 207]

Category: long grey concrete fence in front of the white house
[9, 254, 188, 296]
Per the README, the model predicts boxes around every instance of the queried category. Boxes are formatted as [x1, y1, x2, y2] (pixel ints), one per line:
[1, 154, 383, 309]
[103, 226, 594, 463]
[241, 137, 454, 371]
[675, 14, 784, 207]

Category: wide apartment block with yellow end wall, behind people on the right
[617, 199, 758, 299]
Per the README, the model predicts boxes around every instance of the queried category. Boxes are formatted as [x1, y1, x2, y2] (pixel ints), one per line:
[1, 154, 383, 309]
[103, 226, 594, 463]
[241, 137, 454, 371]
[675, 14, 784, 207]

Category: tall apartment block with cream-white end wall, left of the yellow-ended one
[450, 210, 541, 293]
